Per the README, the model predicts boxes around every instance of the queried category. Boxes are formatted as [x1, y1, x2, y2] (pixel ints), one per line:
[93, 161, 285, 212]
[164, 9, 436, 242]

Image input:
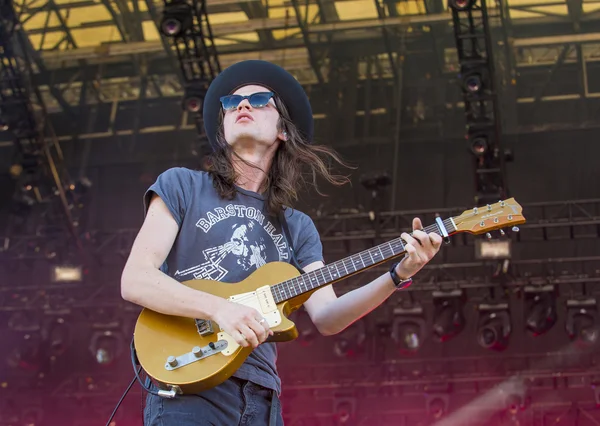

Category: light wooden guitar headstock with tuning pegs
[452, 198, 526, 235]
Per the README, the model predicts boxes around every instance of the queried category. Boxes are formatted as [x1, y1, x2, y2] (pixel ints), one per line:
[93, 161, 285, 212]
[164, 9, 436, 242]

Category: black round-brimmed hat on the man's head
[203, 60, 314, 150]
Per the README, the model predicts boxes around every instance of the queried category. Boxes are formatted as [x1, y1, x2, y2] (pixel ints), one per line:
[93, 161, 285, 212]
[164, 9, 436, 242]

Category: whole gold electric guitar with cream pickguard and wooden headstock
[134, 198, 525, 397]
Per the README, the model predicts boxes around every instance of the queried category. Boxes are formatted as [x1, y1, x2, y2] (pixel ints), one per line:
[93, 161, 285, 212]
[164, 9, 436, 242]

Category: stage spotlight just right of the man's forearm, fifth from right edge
[392, 306, 425, 354]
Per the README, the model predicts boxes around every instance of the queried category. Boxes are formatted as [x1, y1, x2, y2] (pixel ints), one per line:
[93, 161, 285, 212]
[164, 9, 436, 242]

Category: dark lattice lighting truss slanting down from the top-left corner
[0, 0, 82, 250]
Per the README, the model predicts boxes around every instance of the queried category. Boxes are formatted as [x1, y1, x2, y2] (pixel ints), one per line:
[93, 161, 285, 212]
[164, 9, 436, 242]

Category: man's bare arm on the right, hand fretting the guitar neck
[304, 219, 442, 336]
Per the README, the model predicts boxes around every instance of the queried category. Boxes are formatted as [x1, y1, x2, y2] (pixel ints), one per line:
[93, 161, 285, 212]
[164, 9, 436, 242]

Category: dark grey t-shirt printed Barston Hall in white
[144, 167, 323, 392]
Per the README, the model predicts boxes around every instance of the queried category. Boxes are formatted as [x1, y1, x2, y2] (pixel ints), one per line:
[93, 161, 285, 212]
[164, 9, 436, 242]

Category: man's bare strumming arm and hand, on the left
[121, 194, 272, 347]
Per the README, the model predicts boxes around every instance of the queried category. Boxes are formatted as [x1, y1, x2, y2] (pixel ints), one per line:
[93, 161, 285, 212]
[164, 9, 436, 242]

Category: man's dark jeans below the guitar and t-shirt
[144, 377, 283, 426]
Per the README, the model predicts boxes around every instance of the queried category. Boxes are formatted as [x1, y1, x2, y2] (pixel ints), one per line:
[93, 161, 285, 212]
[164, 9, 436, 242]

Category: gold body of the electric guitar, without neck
[134, 262, 311, 394]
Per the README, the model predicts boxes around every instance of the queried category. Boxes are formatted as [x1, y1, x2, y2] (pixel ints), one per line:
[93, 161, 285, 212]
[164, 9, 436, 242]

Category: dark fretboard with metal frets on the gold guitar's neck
[271, 218, 456, 303]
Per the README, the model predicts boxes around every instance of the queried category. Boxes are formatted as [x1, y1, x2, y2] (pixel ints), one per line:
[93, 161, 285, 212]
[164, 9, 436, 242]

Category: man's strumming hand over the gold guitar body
[212, 300, 273, 348]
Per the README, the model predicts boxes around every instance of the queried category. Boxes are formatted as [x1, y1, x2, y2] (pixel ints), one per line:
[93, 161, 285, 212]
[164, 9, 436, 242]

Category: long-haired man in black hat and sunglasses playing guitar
[121, 61, 441, 426]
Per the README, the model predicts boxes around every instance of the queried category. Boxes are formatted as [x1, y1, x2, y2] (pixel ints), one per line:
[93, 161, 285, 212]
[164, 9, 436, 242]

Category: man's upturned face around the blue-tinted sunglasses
[223, 85, 283, 147]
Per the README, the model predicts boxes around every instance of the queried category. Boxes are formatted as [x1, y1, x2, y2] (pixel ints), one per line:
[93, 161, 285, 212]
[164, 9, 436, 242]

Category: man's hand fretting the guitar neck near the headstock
[396, 217, 442, 279]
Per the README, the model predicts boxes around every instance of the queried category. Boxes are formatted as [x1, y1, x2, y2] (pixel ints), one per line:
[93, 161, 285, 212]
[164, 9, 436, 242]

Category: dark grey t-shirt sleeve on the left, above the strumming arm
[144, 167, 191, 227]
